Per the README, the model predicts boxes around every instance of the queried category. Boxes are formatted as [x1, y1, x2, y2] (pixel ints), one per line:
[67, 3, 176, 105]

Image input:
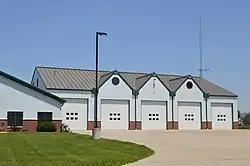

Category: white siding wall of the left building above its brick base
[0, 76, 61, 120]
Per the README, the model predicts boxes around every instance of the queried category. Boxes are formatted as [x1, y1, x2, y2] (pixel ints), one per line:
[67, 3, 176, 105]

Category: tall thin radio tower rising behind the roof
[199, 14, 210, 78]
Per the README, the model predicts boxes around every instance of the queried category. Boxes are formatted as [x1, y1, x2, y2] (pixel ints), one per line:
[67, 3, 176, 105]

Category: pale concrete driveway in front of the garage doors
[79, 130, 250, 166]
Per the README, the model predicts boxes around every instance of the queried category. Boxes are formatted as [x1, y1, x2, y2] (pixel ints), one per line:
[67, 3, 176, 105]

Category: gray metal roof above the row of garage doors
[35, 67, 237, 96]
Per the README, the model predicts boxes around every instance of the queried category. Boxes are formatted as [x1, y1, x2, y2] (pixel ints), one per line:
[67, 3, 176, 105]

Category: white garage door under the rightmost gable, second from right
[178, 102, 201, 130]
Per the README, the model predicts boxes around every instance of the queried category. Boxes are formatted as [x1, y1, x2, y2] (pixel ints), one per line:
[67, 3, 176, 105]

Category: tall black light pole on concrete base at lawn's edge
[92, 32, 107, 139]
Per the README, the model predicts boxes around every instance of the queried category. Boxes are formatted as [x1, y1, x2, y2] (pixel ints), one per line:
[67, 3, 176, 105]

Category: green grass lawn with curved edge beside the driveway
[0, 133, 153, 166]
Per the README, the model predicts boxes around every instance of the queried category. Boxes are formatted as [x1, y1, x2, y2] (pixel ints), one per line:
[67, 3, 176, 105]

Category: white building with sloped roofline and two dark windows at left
[0, 71, 65, 131]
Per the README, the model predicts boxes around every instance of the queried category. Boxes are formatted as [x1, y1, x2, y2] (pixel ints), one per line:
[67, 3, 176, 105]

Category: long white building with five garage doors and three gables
[31, 67, 238, 130]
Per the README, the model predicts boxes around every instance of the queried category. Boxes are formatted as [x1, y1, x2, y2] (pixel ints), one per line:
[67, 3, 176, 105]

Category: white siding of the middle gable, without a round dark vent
[137, 77, 172, 121]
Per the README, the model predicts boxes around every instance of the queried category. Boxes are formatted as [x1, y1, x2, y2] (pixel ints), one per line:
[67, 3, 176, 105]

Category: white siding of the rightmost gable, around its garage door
[174, 79, 206, 121]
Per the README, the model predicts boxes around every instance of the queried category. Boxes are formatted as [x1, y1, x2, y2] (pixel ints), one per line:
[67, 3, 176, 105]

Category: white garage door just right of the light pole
[101, 100, 129, 130]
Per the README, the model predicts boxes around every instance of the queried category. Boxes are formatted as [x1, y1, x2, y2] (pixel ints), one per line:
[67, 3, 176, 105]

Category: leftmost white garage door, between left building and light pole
[62, 99, 88, 131]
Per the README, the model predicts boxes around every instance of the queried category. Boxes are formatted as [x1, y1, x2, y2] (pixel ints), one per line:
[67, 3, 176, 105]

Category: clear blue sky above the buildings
[0, 0, 250, 112]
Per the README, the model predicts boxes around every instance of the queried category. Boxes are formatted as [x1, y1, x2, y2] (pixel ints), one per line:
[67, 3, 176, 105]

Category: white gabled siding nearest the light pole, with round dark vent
[98, 75, 135, 121]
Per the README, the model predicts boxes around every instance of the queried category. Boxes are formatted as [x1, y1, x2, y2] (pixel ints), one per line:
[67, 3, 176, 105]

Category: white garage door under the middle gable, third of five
[141, 101, 167, 130]
